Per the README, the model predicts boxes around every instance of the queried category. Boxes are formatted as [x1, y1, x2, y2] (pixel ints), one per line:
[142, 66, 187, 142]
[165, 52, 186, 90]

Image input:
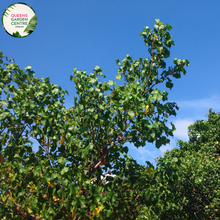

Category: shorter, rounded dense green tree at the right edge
[144, 109, 220, 219]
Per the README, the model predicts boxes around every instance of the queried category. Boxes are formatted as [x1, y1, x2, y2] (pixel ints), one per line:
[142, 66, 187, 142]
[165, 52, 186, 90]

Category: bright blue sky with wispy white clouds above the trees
[0, 0, 220, 168]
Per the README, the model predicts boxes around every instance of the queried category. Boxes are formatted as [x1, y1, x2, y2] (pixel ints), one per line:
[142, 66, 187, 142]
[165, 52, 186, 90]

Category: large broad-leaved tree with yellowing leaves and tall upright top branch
[0, 19, 189, 219]
